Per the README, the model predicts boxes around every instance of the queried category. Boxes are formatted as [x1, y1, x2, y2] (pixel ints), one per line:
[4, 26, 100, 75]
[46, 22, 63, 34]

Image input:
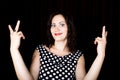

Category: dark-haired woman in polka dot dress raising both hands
[9, 13, 107, 80]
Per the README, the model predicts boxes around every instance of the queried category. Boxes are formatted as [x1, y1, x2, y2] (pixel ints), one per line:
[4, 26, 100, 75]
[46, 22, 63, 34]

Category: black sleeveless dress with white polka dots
[37, 45, 82, 80]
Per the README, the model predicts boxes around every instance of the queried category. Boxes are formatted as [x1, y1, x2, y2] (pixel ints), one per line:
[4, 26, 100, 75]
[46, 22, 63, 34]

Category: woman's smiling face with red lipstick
[50, 14, 68, 41]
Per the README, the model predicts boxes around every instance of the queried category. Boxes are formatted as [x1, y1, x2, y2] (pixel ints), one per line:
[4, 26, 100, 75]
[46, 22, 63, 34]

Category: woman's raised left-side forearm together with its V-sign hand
[9, 20, 39, 80]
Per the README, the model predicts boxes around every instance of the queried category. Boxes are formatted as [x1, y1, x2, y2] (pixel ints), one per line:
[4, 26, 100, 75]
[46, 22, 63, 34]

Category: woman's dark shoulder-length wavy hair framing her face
[46, 11, 77, 52]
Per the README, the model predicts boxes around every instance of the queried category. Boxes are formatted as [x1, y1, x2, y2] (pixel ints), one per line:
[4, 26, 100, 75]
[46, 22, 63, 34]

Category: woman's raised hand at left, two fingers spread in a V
[8, 20, 25, 49]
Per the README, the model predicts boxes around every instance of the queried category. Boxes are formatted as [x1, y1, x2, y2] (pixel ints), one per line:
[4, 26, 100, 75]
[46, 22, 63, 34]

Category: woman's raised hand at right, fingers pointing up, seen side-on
[94, 26, 108, 55]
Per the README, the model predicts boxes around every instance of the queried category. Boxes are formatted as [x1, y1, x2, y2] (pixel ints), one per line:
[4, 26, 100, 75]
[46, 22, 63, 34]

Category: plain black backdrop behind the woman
[0, 0, 120, 80]
